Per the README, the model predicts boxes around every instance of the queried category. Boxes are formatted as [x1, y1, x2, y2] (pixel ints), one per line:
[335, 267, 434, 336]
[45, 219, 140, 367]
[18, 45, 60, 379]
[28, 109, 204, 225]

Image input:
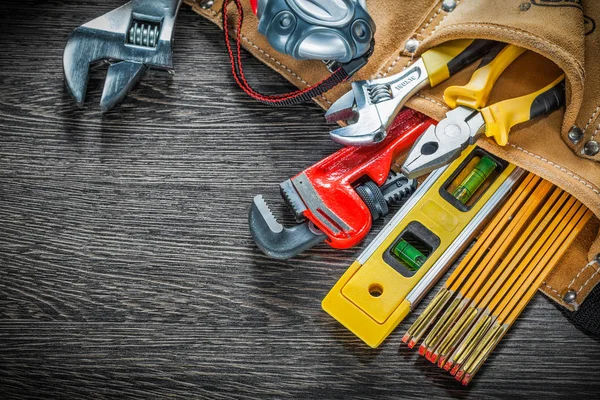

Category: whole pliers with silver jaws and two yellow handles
[402, 43, 565, 179]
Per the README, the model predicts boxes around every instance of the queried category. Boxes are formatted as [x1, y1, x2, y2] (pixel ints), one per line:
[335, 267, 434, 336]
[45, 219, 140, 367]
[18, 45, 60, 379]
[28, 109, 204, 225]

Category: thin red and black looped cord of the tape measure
[222, 0, 349, 106]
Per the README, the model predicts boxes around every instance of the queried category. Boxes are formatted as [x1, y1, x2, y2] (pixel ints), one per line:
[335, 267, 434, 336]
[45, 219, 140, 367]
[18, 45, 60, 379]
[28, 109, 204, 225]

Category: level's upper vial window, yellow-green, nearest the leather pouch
[440, 148, 508, 211]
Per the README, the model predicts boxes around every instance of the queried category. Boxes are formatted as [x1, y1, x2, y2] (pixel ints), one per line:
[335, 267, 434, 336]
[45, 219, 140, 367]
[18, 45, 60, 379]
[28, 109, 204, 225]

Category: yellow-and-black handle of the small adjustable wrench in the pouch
[421, 39, 496, 87]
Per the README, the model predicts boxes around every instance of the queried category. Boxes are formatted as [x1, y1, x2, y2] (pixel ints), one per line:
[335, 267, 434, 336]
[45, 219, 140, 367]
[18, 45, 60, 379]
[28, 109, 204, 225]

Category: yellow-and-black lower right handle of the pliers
[480, 75, 565, 146]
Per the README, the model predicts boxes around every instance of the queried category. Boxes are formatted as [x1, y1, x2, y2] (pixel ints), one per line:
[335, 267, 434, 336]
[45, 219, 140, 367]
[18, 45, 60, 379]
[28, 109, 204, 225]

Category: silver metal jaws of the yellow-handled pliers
[402, 106, 485, 179]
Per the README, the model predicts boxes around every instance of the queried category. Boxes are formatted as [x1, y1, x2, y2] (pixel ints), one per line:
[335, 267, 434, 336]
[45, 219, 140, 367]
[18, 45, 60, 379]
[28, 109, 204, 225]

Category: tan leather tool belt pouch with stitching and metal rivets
[185, 0, 600, 316]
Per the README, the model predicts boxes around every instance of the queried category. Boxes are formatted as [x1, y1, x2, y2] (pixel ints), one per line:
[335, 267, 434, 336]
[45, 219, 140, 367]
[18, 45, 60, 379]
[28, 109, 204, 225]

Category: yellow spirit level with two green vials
[322, 146, 523, 347]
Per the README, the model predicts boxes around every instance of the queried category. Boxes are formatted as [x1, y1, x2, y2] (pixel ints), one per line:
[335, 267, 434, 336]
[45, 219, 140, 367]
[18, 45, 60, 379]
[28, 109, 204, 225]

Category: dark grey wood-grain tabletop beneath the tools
[0, 0, 600, 399]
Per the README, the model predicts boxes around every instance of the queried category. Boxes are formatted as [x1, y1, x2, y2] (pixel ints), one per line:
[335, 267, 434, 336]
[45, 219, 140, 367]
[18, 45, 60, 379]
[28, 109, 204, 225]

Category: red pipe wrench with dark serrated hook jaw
[248, 109, 435, 259]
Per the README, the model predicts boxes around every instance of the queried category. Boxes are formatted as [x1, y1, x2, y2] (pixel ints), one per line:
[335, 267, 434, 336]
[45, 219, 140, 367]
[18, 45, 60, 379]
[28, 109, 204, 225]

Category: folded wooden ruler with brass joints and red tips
[402, 174, 593, 385]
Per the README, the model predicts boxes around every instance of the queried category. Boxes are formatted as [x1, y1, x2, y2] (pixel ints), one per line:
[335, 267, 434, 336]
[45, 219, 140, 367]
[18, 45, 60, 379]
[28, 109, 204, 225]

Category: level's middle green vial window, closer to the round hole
[383, 221, 440, 277]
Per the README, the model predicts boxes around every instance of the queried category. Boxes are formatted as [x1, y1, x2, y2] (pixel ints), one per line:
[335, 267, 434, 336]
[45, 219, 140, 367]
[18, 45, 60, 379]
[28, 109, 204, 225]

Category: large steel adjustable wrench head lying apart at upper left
[63, 0, 181, 112]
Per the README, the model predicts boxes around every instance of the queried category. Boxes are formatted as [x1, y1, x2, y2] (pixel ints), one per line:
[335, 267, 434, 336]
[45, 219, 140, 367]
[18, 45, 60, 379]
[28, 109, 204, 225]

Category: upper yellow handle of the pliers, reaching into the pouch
[444, 44, 525, 110]
